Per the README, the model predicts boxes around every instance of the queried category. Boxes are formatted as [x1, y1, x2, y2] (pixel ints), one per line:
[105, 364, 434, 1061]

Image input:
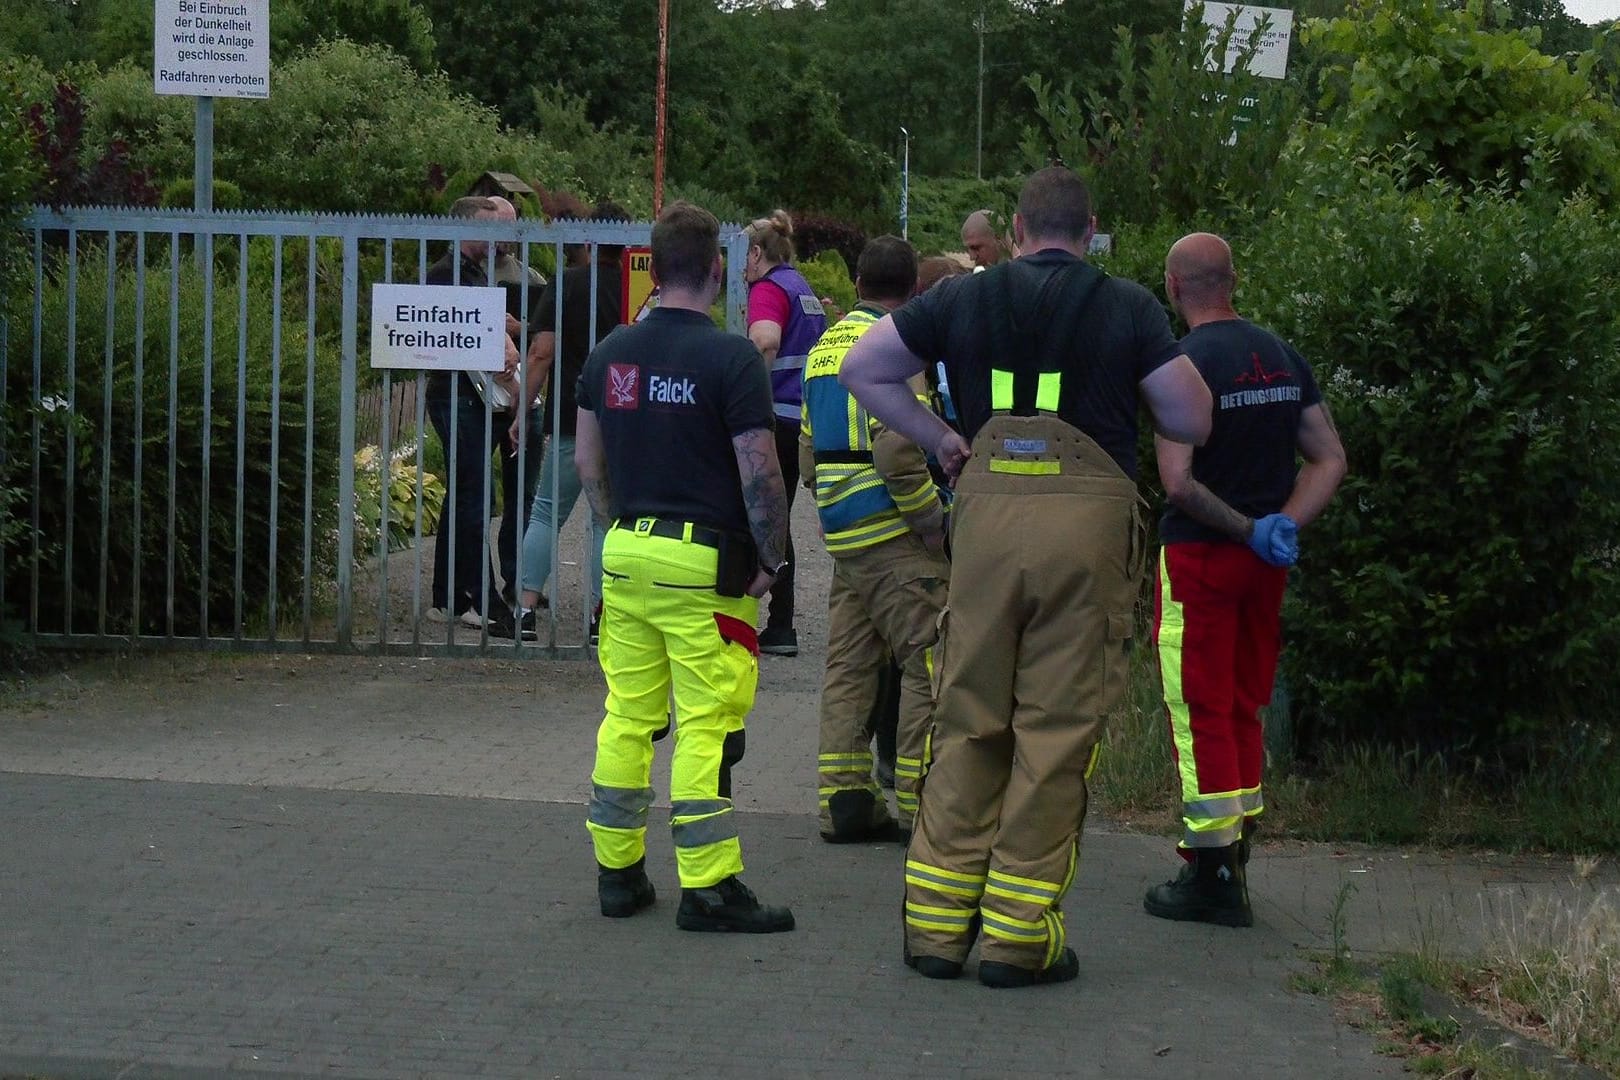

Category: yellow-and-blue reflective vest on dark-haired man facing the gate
[800, 308, 935, 555]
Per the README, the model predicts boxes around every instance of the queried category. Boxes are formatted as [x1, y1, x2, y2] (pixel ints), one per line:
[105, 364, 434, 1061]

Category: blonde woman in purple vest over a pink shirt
[742, 210, 826, 656]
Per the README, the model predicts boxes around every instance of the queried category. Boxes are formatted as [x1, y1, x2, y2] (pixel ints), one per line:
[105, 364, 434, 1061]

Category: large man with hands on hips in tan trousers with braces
[839, 167, 1210, 986]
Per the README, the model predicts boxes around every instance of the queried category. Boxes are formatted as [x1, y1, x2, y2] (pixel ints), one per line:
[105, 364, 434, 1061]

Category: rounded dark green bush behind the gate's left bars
[3, 240, 340, 635]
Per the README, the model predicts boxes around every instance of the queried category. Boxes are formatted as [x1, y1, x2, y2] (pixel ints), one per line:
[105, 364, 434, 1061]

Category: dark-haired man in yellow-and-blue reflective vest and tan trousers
[799, 236, 951, 844]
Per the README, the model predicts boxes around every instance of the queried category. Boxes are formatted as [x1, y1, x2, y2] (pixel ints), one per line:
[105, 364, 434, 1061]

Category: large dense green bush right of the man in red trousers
[1238, 147, 1620, 758]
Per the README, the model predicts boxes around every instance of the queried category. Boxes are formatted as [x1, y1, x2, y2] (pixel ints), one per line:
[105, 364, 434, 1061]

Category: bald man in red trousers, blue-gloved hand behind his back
[1144, 233, 1346, 926]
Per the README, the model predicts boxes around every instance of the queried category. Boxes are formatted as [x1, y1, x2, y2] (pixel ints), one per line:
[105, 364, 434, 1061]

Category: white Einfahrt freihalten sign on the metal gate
[371, 285, 507, 371]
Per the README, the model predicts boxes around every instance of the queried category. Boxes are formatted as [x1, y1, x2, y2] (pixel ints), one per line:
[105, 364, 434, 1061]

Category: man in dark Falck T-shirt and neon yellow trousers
[575, 202, 794, 933]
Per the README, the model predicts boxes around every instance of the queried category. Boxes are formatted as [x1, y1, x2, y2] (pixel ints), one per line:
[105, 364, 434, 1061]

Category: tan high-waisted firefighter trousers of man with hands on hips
[906, 415, 1147, 970]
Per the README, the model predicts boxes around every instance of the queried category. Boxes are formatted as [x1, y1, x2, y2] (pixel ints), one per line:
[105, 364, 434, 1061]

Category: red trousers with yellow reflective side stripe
[1153, 542, 1288, 848]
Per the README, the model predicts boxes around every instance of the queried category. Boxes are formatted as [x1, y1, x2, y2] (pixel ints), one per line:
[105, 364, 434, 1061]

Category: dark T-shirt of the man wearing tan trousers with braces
[894, 249, 1181, 476]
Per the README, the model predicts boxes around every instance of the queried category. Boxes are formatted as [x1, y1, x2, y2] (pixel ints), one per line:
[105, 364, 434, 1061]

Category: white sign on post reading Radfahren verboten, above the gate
[152, 0, 271, 97]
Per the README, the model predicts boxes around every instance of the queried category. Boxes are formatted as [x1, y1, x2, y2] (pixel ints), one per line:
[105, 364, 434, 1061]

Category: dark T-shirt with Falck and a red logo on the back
[575, 308, 771, 533]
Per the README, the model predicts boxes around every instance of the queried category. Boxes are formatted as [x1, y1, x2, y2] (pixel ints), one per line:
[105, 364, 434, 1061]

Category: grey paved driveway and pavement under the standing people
[0, 501, 1589, 1078]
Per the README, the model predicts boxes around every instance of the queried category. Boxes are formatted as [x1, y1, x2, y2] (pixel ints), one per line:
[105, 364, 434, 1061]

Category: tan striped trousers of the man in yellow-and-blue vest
[816, 533, 951, 837]
